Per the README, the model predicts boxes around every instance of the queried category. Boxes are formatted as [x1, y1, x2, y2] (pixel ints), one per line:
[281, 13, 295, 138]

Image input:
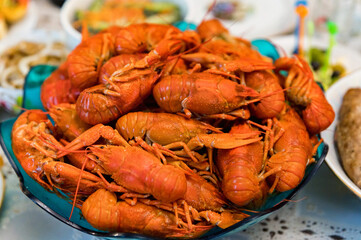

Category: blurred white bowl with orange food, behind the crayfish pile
[60, 0, 193, 49]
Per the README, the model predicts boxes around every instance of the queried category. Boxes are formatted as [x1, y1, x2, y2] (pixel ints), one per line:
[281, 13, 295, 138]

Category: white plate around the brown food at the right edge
[321, 70, 361, 198]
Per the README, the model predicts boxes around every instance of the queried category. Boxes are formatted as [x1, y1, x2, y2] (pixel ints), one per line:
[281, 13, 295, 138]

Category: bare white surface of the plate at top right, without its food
[193, 0, 297, 39]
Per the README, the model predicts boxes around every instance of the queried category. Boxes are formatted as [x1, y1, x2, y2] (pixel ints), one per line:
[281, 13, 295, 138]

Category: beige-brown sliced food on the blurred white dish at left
[0, 41, 66, 89]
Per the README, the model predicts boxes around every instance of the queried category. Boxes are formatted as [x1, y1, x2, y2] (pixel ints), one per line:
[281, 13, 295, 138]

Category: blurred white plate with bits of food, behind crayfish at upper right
[192, 0, 296, 39]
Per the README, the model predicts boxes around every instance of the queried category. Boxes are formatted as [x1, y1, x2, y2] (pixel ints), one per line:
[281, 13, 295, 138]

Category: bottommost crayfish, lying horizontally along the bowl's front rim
[81, 189, 205, 237]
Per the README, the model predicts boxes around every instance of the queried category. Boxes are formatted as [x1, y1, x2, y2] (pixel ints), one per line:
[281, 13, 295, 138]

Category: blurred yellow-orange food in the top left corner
[0, 0, 29, 39]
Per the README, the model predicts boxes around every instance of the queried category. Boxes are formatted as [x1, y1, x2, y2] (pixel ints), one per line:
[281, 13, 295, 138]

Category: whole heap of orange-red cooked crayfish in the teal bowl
[12, 20, 335, 238]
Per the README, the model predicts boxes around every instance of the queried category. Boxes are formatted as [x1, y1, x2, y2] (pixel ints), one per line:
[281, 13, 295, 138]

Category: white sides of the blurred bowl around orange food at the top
[60, 0, 197, 50]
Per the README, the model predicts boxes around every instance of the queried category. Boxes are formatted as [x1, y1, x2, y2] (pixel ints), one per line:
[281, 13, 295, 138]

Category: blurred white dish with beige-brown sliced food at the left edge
[0, 29, 67, 112]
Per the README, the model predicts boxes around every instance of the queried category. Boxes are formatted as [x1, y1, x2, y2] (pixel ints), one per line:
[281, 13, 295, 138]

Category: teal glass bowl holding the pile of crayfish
[0, 40, 328, 239]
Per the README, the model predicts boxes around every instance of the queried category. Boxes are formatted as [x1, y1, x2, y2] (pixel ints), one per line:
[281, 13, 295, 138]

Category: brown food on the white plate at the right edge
[335, 88, 361, 188]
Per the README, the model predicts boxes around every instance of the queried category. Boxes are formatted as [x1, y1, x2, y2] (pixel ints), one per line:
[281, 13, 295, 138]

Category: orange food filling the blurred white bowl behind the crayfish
[73, 0, 181, 34]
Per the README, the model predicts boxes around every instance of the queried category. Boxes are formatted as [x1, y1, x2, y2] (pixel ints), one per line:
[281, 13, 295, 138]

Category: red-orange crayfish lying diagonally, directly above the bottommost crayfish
[89, 145, 187, 202]
